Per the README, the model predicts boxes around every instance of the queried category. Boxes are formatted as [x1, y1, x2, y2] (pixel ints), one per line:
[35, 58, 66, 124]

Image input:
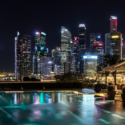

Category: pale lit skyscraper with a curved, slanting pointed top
[61, 26, 71, 74]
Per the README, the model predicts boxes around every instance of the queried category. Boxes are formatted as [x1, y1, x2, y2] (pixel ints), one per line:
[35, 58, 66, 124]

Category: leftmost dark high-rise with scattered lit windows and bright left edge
[15, 32, 32, 80]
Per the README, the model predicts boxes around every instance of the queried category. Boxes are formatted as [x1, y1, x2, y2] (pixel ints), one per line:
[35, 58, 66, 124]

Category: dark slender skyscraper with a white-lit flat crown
[78, 24, 86, 74]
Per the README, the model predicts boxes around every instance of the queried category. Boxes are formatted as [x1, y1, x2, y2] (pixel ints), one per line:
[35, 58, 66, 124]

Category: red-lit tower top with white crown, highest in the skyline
[110, 16, 117, 33]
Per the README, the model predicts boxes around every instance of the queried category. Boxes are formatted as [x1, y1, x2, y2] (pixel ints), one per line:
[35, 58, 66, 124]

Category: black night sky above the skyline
[0, 0, 125, 72]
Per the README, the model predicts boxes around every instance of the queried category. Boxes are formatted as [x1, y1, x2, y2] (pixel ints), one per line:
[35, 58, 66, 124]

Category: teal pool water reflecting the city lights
[0, 92, 125, 125]
